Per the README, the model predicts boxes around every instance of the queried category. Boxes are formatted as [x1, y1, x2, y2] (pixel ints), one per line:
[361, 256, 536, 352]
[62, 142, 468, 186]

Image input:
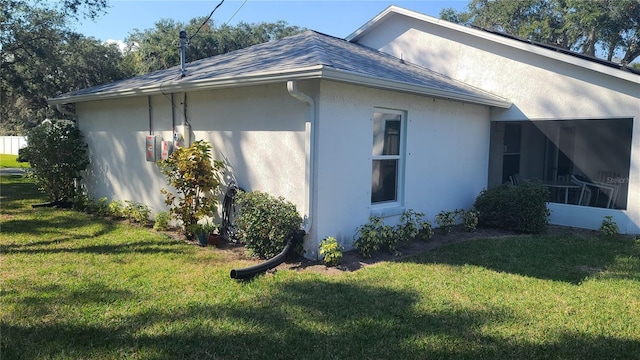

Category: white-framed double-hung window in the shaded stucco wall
[371, 110, 403, 204]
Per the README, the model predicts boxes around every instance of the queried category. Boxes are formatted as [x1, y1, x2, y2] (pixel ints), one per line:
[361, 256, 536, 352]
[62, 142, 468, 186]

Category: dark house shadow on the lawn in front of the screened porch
[405, 235, 640, 285]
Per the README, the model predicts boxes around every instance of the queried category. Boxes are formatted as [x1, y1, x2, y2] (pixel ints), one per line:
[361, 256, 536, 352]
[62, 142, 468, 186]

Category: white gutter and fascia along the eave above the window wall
[322, 67, 512, 109]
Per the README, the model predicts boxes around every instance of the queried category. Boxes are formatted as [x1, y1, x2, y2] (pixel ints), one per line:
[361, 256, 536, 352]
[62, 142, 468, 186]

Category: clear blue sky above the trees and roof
[75, 0, 469, 41]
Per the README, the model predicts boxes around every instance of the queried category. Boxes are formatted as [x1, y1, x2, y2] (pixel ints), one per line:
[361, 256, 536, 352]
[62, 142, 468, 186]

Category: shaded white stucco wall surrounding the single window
[314, 81, 490, 258]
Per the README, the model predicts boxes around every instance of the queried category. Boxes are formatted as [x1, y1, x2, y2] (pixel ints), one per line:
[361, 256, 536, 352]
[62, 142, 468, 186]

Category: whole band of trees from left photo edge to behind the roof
[0, 0, 301, 135]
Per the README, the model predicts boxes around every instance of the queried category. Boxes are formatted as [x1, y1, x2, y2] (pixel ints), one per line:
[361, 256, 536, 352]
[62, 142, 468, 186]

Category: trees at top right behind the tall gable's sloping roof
[440, 0, 640, 64]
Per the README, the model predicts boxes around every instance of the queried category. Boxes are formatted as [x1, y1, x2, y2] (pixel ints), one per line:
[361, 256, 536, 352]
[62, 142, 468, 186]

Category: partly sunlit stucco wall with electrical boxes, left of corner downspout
[77, 84, 306, 221]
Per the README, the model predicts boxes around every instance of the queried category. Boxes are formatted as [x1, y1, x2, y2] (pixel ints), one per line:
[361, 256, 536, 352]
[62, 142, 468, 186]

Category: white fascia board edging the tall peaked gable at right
[346, 5, 640, 84]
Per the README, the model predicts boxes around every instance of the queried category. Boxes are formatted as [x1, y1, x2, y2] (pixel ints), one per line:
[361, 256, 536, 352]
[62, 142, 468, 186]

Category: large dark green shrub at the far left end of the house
[22, 122, 89, 201]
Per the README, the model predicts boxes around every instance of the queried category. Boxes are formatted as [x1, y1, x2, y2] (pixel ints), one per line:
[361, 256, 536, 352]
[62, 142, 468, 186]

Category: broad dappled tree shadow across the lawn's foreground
[1, 280, 640, 359]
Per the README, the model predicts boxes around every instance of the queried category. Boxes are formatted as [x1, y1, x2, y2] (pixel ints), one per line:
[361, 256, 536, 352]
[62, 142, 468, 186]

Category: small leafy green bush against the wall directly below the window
[353, 216, 395, 258]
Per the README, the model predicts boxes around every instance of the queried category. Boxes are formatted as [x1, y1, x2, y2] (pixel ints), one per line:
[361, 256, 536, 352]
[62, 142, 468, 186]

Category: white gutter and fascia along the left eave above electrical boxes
[47, 65, 322, 105]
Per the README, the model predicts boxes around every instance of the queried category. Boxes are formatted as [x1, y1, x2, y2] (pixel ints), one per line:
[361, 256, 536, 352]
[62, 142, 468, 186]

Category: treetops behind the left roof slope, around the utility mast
[124, 18, 302, 75]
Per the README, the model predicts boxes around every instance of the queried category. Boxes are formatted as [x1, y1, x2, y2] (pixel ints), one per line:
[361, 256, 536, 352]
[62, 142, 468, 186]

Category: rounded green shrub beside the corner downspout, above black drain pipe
[235, 191, 302, 259]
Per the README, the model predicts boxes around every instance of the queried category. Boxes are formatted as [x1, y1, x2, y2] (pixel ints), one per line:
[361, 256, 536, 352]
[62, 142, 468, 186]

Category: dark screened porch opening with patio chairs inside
[489, 119, 633, 209]
